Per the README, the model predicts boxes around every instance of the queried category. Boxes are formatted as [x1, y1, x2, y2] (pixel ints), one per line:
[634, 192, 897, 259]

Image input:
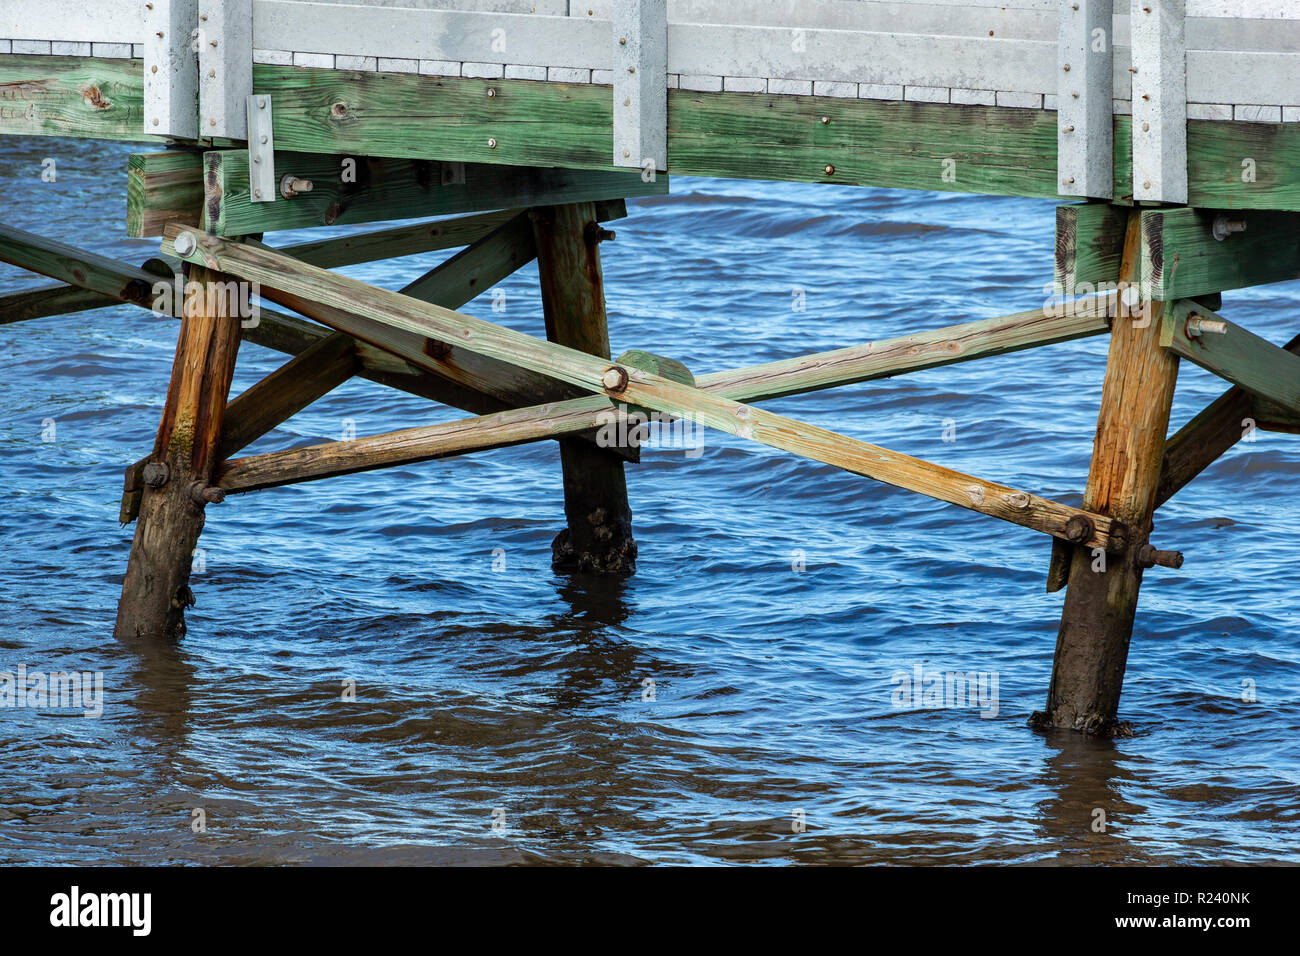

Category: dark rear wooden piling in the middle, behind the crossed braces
[533, 203, 637, 574]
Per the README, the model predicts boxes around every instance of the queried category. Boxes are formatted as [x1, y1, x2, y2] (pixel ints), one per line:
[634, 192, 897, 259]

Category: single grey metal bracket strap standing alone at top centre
[612, 0, 668, 176]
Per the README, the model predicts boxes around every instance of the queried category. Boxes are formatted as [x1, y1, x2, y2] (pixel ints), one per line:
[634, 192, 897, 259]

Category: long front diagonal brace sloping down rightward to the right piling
[164, 226, 1123, 550]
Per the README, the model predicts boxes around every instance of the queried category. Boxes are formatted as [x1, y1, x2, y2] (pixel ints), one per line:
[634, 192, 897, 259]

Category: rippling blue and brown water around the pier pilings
[0, 139, 1300, 864]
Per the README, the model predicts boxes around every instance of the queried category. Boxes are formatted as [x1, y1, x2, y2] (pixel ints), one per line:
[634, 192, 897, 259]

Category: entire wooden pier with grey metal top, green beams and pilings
[0, 0, 1300, 735]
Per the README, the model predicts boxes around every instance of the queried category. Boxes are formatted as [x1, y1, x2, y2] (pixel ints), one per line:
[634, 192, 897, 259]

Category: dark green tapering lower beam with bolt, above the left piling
[203, 150, 668, 235]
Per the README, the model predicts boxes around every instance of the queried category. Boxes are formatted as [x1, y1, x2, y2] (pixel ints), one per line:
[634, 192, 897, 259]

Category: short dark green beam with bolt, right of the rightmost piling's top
[1141, 208, 1300, 302]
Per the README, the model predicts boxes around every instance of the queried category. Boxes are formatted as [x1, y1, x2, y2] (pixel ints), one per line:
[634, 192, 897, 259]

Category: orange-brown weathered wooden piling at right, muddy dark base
[1031, 212, 1178, 735]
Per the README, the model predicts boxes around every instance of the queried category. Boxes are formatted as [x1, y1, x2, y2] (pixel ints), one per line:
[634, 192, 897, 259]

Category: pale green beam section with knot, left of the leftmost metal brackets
[0, 53, 166, 143]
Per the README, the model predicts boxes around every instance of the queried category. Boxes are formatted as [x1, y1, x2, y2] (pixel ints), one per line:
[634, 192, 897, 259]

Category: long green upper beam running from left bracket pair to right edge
[254, 65, 1300, 209]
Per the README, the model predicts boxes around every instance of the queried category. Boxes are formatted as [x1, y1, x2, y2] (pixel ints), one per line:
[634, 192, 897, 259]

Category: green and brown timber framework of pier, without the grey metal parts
[0, 31, 1300, 735]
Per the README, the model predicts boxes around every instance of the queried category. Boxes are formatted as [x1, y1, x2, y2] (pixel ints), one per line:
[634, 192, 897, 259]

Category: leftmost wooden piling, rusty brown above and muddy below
[114, 265, 241, 640]
